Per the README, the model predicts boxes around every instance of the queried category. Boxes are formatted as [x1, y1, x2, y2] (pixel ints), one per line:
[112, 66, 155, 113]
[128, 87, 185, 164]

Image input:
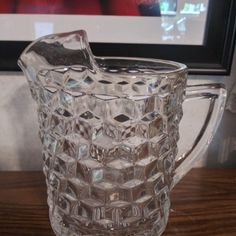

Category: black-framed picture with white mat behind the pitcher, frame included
[0, 0, 236, 75]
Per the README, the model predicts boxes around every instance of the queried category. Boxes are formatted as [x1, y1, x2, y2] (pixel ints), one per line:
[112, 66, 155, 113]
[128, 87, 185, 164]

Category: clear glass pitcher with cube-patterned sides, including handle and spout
[18, 30, 226, 236]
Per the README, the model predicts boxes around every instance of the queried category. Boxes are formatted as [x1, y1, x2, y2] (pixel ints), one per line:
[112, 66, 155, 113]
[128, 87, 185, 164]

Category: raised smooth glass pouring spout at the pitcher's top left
[18, 30, 97, 81]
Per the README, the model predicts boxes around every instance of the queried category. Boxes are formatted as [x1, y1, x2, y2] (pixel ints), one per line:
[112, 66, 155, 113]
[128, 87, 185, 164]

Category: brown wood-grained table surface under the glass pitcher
[0, 168, 236, 236]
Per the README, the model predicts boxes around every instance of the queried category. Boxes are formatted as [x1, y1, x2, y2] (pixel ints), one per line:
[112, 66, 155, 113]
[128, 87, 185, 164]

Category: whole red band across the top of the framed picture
[0, 0, 140, 16]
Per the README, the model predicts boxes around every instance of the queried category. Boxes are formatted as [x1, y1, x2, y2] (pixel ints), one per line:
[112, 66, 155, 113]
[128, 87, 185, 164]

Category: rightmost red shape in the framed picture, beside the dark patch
[107, 0, 140, 16]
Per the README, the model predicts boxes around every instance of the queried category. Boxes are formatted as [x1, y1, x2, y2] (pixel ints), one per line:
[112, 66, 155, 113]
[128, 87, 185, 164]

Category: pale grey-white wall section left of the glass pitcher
[0, 72, 41, 170]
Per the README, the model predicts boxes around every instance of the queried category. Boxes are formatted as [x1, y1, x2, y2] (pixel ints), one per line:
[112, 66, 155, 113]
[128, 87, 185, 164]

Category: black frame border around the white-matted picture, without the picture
[0, 0, 236, 75]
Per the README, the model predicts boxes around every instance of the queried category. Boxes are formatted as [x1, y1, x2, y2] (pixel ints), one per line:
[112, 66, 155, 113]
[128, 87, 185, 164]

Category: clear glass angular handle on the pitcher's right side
[171, 83, 227, 188]
